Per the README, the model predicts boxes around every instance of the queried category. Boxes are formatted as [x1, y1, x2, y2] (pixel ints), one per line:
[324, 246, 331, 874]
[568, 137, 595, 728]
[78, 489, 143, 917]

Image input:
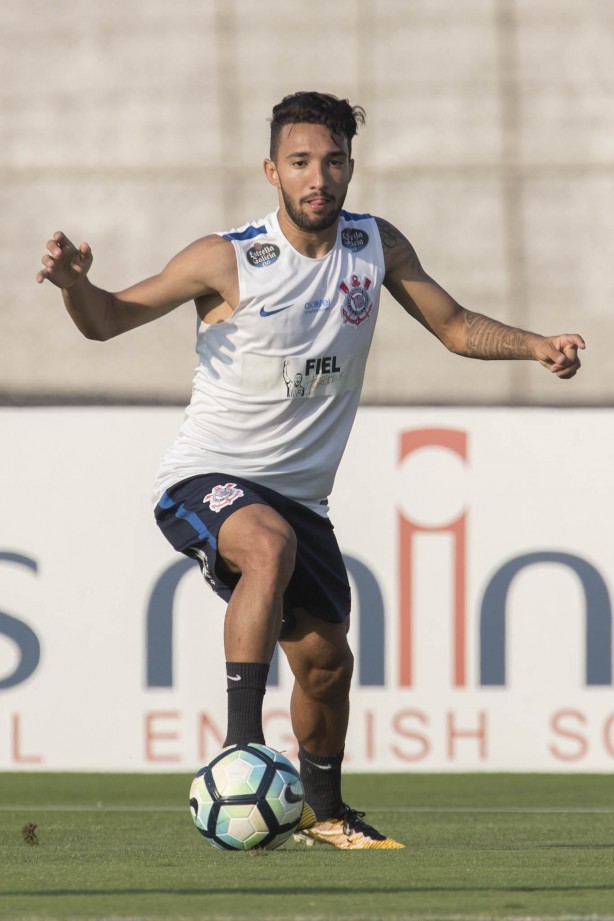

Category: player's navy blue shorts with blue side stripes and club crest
[155, 473, 351, 636]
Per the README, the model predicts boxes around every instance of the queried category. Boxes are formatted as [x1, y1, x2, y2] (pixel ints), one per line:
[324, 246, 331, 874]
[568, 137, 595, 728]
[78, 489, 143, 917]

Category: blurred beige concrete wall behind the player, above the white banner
[0, 0, 614, 404]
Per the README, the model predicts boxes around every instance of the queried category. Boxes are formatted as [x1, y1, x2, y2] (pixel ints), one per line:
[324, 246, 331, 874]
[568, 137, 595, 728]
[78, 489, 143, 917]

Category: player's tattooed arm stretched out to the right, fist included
[376, 218, 585, 379]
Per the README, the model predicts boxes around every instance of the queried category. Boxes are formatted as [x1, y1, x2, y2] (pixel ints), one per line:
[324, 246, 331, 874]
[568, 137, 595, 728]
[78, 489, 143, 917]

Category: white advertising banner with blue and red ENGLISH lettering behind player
[0, 407, 614, 773]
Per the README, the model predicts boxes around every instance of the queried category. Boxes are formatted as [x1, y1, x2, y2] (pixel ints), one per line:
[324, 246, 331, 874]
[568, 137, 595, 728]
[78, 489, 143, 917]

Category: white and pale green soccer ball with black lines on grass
[190, 742, 305, 851]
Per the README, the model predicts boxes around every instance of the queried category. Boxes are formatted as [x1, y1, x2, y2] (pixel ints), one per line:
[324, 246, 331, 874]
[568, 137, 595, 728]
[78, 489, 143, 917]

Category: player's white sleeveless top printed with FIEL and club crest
[154, 211, 384, 515]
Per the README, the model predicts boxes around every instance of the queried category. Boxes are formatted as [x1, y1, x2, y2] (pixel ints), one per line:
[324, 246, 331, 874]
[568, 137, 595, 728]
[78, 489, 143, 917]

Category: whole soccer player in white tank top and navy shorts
[37, 92, 584, 848]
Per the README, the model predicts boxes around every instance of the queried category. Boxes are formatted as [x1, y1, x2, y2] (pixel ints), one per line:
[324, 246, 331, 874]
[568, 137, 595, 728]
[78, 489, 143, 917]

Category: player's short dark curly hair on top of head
[270, 91, 366, 160]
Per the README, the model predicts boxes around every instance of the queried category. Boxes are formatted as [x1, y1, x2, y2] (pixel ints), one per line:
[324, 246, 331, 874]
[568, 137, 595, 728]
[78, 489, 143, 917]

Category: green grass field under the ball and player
[0, 773, 614, 921]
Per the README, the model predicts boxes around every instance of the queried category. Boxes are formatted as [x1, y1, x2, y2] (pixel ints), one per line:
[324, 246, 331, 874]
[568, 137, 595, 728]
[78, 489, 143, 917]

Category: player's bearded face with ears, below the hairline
[265, 123, 354, 233]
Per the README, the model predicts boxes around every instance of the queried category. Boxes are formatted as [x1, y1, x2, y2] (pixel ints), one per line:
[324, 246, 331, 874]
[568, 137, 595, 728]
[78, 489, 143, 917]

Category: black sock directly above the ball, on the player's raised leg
[224, 662, 269, 748]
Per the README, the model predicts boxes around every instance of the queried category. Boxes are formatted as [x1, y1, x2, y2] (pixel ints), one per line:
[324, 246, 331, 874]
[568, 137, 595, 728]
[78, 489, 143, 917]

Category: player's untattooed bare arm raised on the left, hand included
[36, 231, 238, 340]
